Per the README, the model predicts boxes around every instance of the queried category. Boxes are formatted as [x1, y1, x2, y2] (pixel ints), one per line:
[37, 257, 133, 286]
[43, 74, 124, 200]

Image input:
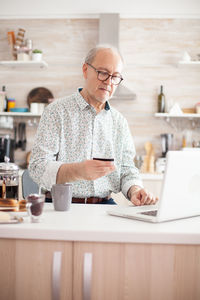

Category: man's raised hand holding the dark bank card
[77, 160, 115, 180]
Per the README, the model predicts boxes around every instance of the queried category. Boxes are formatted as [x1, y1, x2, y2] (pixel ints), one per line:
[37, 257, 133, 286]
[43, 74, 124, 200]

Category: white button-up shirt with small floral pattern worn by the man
[29, 91, 142, 198]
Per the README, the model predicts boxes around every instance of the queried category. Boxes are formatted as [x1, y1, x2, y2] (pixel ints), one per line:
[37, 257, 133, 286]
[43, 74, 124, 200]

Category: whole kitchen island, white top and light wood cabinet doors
[0, 204, 200, 300]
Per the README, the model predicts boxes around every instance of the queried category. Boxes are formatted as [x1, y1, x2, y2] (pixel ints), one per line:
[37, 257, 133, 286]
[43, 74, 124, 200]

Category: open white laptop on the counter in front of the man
[107, 149, 200, 223]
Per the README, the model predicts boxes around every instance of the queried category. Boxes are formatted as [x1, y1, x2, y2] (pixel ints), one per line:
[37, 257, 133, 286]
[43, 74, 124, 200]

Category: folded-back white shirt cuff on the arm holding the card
[41, 161, 64, 191]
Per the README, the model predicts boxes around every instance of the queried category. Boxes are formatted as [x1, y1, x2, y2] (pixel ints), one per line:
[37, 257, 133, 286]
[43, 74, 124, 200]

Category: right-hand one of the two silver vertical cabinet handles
[83, 253, 92, 300]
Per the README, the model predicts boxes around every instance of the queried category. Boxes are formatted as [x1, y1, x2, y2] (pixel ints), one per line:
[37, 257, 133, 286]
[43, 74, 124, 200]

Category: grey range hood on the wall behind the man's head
[99, 13, 136, 100]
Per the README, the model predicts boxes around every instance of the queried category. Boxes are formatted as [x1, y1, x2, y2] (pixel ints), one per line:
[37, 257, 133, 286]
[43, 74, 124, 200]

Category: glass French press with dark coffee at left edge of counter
[0, 158, 19, 200]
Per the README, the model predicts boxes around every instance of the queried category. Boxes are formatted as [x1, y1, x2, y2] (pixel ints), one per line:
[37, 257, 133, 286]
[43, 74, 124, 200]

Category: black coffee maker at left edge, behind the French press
[0, 134, 15, 162]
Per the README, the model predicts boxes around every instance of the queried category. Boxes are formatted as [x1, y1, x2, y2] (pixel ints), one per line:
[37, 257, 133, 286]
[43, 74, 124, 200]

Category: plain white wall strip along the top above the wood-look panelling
[0, 0, 200, 18]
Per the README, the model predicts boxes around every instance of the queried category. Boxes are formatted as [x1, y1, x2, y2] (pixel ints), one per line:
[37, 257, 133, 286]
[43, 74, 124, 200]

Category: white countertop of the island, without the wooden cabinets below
[0, 203, 200, 244]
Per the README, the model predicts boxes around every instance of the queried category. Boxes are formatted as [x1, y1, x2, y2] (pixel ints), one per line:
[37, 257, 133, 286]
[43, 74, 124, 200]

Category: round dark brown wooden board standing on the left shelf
[27, 87, 54, 108]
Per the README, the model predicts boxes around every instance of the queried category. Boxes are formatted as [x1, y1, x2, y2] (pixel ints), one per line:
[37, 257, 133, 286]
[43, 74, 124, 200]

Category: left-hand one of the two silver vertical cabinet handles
[52, 251, 62, 300]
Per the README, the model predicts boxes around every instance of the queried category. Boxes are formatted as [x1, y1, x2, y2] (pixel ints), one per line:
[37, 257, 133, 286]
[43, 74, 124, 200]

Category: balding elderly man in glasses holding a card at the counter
[29, 46, 157, 205]
